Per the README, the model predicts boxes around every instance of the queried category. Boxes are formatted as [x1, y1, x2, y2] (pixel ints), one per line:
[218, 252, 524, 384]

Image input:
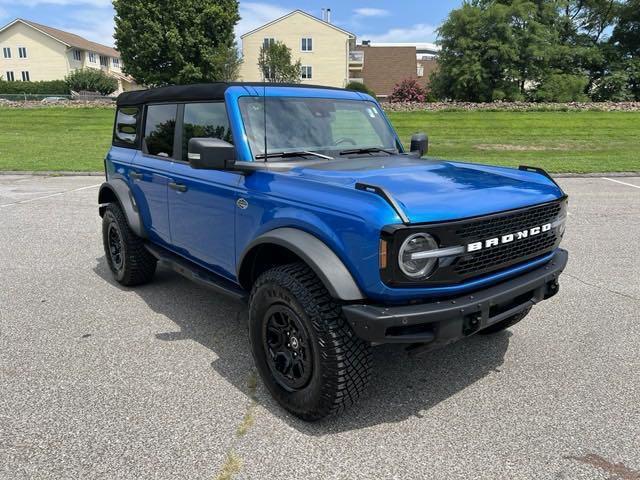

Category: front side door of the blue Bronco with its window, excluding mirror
[168, 102, 241, 279]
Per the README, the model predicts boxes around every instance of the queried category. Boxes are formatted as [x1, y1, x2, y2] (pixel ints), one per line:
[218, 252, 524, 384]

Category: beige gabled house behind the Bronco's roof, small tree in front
[240, 10, 356, 87]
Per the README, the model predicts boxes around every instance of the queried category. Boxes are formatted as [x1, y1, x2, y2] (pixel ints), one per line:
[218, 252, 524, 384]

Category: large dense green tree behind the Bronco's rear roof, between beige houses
[113, 0, 240, 86]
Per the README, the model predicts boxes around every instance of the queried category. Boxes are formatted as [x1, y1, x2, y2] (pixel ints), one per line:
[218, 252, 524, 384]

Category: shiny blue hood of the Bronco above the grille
[289, 155, 563, 223]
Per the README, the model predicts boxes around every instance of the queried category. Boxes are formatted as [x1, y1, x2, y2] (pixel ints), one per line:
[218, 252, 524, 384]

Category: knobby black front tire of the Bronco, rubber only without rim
[249, 263, 371, 421]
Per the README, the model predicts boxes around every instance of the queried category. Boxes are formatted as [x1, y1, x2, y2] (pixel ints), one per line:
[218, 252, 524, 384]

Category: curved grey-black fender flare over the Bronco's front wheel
[238, 227, 365, 301]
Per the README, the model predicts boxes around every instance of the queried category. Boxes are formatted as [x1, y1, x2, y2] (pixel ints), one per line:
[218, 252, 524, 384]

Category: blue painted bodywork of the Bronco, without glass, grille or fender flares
[106, 86, 564, 304]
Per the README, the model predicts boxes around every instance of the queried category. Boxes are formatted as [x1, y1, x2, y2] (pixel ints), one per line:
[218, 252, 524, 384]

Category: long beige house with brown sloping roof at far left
[0, 18, 137, 94]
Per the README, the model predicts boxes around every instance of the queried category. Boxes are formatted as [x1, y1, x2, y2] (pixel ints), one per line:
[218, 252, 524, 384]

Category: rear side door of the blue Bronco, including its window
[129, 103, 178, 244]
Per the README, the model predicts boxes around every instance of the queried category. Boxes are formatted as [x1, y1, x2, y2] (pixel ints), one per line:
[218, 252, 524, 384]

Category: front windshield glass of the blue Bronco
[239, 97, 397, 158]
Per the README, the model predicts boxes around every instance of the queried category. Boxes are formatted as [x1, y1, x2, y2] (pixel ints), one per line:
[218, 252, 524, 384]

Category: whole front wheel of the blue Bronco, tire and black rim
[249, 263, 371, 420]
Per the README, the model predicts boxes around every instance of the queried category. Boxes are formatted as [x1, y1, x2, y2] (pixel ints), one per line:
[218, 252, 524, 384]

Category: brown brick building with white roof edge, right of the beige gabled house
[351, 41, 439, 99]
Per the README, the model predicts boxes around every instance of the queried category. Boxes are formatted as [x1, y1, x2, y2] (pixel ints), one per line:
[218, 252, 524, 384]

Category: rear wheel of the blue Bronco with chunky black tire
[102, 203, 157, 287]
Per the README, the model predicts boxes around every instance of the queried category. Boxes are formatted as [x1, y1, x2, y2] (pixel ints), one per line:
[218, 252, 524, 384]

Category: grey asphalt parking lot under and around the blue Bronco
[0, 176, 640, 480]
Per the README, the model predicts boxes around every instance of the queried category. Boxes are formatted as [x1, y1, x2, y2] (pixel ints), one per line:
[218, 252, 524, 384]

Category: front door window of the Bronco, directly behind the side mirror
[182, 103, 232, 162]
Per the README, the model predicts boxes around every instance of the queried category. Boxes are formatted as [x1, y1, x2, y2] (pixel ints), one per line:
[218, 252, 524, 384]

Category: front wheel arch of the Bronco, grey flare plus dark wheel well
[238, 227, 365, 301]
